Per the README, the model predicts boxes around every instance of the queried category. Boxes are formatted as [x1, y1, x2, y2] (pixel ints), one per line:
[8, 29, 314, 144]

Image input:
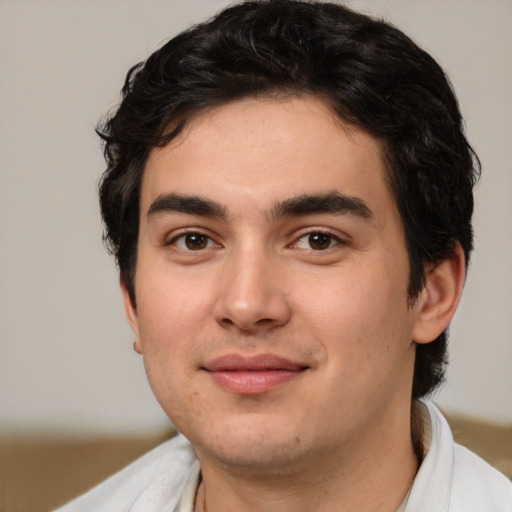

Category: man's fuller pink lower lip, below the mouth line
[210, 370, 303, 395]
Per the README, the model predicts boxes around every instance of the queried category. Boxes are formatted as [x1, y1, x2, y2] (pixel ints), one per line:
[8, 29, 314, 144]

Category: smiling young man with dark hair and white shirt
[54, 0, 512, 512]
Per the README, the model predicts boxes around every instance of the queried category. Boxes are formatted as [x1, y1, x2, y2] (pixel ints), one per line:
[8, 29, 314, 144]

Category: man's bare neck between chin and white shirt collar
[196, 404, 418, 512]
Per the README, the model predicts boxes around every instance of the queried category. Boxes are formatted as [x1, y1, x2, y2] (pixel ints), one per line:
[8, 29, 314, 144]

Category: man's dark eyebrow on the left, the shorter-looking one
[147, 194, 227, 220]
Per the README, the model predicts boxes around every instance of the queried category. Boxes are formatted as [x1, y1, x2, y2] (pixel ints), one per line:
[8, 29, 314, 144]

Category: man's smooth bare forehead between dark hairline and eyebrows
[141, 97, 390, 217]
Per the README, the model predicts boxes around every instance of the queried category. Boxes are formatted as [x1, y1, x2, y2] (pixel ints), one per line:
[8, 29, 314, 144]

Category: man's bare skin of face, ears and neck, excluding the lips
[123, 97, 464, 512]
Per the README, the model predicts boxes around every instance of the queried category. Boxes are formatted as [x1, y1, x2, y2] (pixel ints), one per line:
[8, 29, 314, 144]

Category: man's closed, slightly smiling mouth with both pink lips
[201, 354, 309, 395]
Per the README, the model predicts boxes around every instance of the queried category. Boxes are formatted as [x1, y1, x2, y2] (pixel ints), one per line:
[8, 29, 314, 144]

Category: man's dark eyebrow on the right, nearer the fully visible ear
[272, 192, 373, 220]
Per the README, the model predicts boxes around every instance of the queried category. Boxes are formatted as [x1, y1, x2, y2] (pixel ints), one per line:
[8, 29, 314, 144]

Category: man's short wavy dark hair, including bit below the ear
[97, 0, 480, 398]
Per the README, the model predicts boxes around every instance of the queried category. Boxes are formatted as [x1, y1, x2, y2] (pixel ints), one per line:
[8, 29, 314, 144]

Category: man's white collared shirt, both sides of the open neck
[55, 404, 512, 512]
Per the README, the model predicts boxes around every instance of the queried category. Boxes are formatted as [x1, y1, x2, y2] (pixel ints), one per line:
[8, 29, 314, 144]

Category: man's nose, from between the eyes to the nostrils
[214, 251, 291, 334]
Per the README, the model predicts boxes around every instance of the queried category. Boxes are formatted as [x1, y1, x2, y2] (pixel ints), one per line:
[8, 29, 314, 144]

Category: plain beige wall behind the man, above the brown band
[0, 0, 512, 436]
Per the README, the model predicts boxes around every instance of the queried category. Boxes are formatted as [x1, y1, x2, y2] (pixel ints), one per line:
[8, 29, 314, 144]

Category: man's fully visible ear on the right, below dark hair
[412, 242, 466, 343]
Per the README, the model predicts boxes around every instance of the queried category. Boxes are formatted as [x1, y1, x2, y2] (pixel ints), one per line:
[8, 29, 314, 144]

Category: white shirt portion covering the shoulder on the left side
[55, 435, 196, 512]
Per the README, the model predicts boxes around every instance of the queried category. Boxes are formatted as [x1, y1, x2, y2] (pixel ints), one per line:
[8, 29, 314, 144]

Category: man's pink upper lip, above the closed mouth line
[203, 354, 308, 372]
